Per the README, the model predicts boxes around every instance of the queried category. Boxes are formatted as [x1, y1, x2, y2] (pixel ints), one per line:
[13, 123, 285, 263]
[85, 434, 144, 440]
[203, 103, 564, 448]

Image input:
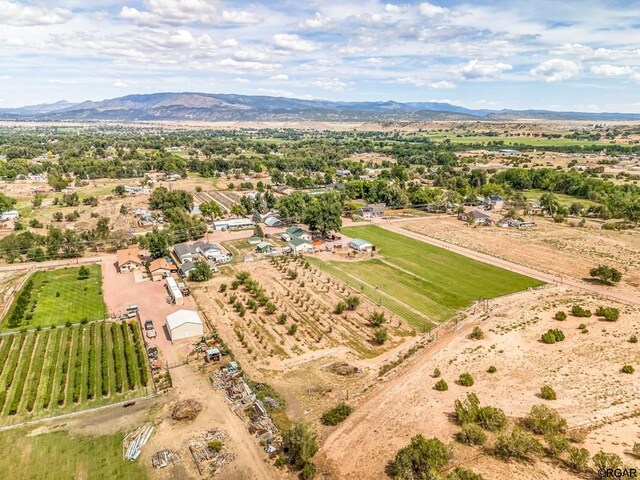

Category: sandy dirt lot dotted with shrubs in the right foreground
[319, 287, 640, 480]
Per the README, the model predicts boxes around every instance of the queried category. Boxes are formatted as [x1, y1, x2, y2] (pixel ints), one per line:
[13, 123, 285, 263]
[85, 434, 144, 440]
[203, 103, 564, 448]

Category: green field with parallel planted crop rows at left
[0, 322, 151, 424]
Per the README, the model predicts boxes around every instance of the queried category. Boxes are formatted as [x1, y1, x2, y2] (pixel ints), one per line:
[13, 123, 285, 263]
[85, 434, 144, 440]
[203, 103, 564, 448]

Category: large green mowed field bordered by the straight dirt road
[311, 225, 543, 329]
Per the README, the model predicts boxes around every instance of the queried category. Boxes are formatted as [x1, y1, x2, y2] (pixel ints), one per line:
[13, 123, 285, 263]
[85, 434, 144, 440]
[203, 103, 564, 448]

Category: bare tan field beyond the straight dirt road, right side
[398, 214, 640, 291]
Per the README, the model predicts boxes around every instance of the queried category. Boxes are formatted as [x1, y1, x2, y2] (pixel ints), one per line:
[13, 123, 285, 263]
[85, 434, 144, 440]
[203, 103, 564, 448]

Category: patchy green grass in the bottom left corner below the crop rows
[0, 429, 148, 480]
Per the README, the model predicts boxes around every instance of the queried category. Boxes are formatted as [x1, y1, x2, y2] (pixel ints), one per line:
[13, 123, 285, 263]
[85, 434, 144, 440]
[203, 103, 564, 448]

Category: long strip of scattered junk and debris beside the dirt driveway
[211, 362, 279, 453]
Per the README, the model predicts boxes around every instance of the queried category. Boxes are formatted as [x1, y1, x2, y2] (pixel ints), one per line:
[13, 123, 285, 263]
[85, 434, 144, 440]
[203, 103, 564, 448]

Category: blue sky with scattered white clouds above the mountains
[0, 0, 640, 112]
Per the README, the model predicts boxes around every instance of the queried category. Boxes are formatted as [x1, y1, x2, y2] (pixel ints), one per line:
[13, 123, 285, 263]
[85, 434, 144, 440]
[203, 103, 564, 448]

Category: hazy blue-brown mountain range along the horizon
[0, 92, 640, 122]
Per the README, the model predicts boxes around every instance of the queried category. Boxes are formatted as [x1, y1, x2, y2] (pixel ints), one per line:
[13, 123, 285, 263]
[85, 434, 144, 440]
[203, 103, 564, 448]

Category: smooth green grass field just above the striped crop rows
[2, 265, 107, 331]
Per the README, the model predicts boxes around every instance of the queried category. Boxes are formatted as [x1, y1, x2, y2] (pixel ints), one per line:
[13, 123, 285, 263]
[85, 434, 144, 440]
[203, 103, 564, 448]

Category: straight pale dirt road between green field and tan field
[372, 221, 640, 305]
